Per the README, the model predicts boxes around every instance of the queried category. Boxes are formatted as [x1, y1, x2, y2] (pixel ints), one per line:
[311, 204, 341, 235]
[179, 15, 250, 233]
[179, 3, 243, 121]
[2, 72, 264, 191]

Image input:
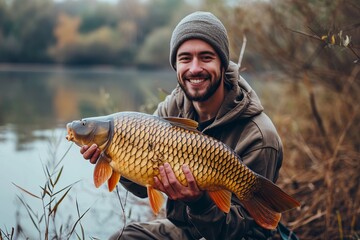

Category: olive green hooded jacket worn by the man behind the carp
[122, 62, 283, 240]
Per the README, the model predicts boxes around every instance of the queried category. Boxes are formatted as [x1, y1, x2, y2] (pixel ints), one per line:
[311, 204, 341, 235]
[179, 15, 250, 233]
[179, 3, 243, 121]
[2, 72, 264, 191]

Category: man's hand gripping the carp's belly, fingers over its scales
[154, 163, 204, 202]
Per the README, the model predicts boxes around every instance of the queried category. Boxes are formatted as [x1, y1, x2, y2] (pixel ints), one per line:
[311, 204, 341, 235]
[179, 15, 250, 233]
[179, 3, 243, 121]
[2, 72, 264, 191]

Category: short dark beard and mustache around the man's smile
[178, 71, 222, 102]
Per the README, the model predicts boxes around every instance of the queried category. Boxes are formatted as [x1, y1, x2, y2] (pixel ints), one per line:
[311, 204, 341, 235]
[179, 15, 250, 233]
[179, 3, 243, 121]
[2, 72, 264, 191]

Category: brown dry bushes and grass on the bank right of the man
[211, 0, 360, 239]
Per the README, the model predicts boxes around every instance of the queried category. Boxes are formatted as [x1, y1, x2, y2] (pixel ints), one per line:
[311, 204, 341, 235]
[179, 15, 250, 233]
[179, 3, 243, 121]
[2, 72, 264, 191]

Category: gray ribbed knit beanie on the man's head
[170, 12, 229, 70]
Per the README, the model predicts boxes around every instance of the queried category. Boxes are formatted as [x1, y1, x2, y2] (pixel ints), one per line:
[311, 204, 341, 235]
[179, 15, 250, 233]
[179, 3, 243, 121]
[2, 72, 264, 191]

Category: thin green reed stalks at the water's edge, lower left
[0, 134, 90, 240]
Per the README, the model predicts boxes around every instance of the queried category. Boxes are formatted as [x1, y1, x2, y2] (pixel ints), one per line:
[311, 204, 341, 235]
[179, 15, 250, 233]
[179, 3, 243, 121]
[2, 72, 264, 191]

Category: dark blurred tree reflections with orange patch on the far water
[0, 68, 176, 150]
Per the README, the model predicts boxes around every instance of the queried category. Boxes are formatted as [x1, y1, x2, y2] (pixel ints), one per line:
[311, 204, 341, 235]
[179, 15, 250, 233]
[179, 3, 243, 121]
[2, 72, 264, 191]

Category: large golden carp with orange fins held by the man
[66, 112, 300, 229]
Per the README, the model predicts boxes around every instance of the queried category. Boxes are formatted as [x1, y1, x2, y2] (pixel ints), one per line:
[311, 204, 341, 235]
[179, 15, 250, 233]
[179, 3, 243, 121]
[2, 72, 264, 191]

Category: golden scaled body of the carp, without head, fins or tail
[106, 113, 257, 200]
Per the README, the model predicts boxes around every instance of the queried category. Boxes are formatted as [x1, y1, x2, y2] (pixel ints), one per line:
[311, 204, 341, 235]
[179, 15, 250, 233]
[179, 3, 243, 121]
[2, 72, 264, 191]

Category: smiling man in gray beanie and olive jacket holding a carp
[80, 12, 282, 240]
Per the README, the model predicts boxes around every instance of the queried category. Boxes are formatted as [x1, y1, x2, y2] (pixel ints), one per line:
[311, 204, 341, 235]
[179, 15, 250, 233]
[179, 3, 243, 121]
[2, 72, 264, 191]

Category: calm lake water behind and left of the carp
[0, 67, 176, 239]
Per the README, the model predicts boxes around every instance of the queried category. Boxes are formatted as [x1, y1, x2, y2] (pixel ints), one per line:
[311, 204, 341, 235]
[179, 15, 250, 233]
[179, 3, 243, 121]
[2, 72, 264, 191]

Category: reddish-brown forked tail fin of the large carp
[241, 176, 300, 229]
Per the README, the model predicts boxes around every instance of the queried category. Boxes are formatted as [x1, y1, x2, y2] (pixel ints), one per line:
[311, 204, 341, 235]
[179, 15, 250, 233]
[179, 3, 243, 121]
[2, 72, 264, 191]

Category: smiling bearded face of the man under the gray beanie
[176, 39, 222, 102]
